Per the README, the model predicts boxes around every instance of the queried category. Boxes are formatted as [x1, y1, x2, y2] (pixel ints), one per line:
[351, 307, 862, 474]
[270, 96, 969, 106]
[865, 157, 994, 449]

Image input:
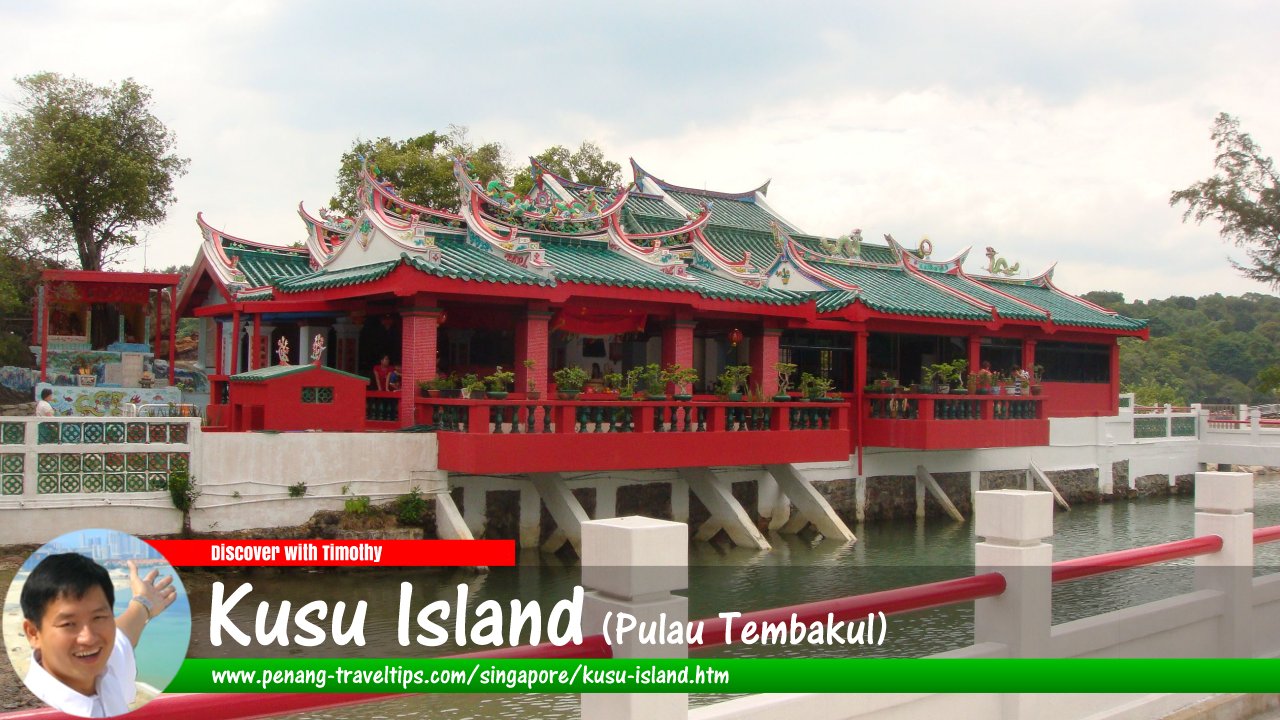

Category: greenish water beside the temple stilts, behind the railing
[225, 477, 1280, 720]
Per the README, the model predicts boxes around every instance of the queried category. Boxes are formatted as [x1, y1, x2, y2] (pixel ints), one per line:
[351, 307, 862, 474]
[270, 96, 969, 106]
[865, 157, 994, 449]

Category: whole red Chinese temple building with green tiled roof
[177, 159, 1147, 473]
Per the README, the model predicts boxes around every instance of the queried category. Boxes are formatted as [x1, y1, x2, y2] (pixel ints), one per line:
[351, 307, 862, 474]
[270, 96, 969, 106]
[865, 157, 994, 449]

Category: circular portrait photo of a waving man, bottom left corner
[4, 529, 191, 717]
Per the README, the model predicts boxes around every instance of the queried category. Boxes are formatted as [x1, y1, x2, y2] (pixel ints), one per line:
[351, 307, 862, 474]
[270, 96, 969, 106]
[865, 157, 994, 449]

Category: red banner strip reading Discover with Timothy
[148, 539, 516, 568]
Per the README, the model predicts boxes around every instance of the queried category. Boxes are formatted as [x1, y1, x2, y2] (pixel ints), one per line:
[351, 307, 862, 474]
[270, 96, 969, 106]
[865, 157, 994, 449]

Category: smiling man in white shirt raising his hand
[22, 553, 177, 717]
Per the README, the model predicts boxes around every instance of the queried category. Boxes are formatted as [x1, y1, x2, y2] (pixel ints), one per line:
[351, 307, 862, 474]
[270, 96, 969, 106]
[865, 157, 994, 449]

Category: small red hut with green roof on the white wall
[230, 365, 369, 432]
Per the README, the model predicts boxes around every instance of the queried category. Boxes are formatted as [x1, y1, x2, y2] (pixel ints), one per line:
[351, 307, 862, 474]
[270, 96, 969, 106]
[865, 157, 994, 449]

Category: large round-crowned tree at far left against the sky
[0, 73, 188, 270]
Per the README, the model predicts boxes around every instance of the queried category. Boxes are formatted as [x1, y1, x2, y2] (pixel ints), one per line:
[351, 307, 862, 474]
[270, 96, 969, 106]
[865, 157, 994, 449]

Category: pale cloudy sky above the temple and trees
[0, 0, 1280, 299]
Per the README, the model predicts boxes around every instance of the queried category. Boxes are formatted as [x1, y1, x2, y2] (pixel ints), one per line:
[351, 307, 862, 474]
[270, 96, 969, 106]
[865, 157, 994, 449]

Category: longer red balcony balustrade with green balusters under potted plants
[416, 397, 852, 474]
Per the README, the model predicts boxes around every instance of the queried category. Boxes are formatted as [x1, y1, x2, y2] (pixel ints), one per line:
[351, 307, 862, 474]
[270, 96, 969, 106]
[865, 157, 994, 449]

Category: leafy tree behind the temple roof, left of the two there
[329, 126, 508, 217]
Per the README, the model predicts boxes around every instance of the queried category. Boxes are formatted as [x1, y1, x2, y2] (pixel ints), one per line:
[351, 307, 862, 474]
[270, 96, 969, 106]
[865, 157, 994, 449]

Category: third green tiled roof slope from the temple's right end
[818, 263, 991, 320]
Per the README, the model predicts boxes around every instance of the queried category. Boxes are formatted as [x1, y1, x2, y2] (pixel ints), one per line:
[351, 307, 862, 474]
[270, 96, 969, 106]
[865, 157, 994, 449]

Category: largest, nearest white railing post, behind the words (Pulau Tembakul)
[581, 516, 689, 720]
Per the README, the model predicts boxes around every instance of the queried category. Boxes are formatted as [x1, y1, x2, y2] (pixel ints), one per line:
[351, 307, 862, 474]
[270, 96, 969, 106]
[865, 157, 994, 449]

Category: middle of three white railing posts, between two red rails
[974, 489, 1053, 657]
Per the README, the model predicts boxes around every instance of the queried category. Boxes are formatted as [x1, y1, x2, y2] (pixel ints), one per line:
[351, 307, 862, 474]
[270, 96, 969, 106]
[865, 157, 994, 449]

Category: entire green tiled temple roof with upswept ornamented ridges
[182, 151, 1146, 336]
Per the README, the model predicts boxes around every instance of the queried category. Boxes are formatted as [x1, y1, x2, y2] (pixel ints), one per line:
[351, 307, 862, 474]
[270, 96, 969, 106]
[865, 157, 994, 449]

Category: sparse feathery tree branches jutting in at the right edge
[1169, 113, 1280, 287]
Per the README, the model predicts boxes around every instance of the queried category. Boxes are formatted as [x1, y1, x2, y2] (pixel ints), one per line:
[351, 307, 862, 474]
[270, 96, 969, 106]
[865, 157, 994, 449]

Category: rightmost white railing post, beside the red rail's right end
[1196, 473, 1253, 657]
